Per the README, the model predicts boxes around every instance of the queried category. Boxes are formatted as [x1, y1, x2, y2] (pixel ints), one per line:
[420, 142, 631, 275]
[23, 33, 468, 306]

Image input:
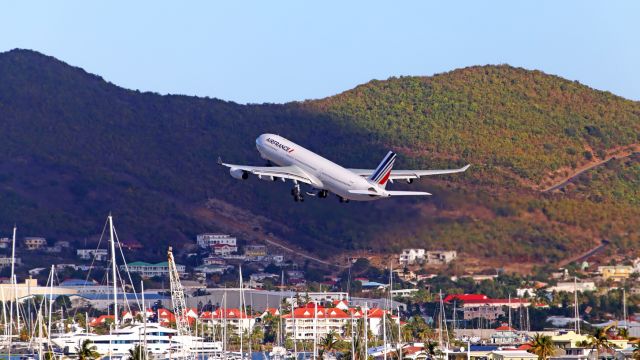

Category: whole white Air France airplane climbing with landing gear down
[218, 134, 470, 203]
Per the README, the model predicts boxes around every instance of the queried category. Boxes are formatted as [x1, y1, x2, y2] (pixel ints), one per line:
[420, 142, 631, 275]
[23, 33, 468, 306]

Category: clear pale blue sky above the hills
[0, 0, 640, 103]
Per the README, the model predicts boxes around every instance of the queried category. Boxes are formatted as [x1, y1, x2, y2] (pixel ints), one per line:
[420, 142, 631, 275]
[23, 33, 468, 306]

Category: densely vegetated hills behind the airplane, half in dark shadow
[0, 50, 640, 263]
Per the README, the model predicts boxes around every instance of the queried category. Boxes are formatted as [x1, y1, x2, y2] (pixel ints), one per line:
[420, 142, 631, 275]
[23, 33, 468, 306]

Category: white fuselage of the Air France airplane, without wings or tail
[256, 134, 384, 201]
